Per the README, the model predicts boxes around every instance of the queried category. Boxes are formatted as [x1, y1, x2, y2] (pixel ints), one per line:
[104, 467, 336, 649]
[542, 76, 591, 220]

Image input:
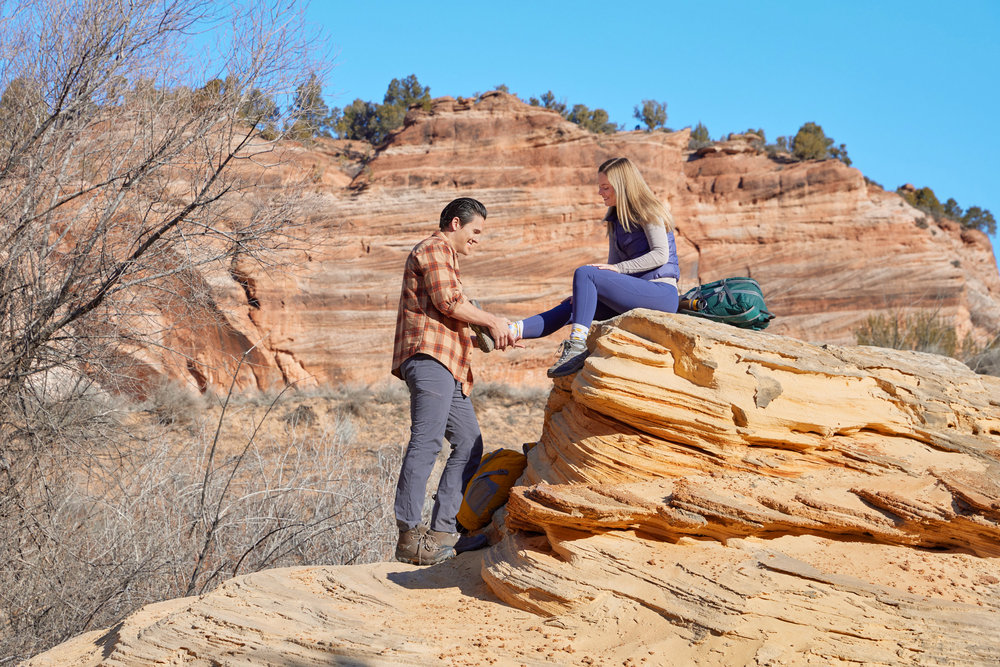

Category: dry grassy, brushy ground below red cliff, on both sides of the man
[0, 382, 544, 664]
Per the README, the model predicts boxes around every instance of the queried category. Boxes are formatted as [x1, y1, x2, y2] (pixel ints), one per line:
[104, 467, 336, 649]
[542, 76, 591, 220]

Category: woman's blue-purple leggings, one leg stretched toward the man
[522, 266, 680, 338]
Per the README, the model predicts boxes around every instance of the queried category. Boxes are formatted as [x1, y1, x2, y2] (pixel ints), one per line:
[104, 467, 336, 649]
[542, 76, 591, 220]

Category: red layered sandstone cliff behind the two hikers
[125, 92, 1000, 388]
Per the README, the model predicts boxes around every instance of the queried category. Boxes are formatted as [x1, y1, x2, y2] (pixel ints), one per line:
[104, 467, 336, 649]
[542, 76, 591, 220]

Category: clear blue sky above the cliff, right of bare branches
[307, 0, 1000, 272]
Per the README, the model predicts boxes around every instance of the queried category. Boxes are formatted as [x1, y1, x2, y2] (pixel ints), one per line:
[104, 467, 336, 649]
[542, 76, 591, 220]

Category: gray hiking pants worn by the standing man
[395, 354, 483, 533]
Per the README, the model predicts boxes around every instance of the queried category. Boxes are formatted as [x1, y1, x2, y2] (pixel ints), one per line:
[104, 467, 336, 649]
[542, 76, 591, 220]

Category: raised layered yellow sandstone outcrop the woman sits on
[483, 311, 1000, 664]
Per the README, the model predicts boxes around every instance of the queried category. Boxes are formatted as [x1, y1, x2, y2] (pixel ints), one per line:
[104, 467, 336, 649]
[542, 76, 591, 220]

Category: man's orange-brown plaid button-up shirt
[392, 232, 472, 396]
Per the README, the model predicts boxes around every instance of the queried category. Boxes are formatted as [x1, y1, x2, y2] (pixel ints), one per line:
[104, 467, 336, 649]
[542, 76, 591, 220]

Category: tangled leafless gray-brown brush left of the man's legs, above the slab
[0, 410, 399, 661]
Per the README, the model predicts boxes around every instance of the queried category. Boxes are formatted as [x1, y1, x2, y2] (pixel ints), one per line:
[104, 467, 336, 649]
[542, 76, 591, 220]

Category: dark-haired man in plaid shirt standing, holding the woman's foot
[392, 197, 513, 565]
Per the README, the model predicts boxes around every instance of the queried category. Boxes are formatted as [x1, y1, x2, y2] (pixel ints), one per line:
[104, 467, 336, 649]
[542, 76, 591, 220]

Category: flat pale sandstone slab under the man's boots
[27, 554, 615, 667]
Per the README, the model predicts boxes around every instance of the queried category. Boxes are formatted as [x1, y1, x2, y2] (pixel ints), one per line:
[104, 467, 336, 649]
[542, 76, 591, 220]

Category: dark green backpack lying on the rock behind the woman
[677, 278, 774, 330]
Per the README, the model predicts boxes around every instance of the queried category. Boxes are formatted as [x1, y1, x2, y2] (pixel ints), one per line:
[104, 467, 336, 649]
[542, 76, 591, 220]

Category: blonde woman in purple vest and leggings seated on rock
[510, 157, 680, 377]
